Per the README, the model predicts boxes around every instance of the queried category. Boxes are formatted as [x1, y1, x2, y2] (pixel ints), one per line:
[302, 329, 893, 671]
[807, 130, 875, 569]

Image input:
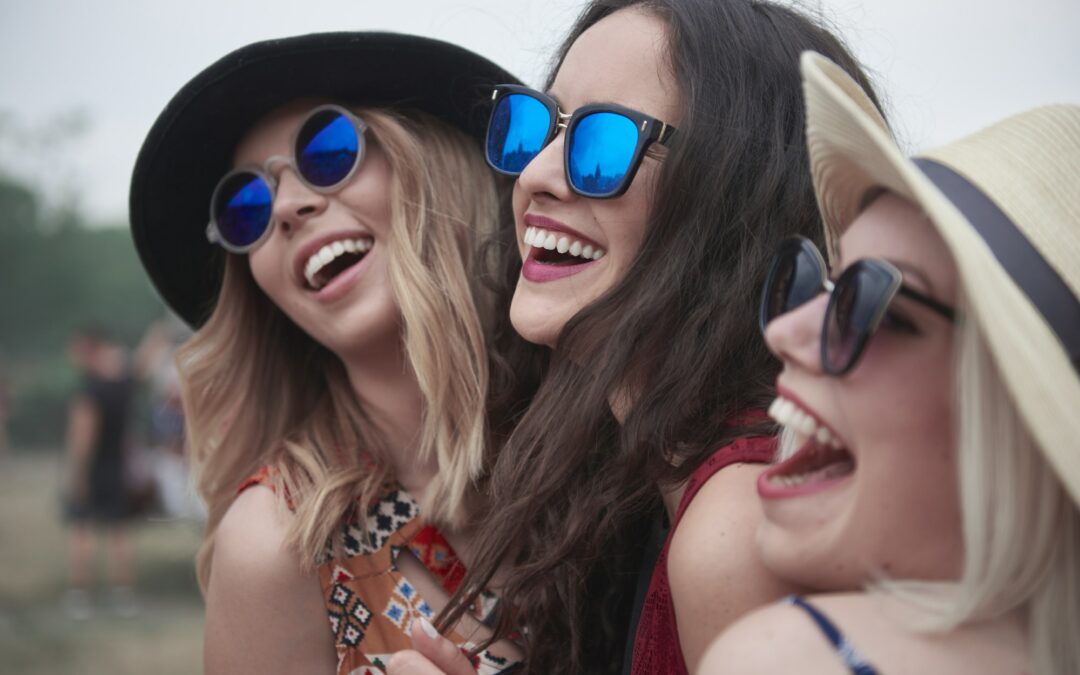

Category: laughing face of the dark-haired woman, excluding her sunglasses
[510, 9, 679, 347]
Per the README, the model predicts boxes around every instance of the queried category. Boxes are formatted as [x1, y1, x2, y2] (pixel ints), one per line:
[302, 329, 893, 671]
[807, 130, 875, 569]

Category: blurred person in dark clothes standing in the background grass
[63, 325, 137, 620]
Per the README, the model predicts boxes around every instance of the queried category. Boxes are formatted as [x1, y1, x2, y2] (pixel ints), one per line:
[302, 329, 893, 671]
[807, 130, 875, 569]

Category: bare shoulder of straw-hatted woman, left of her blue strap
[697, 604, 849, 675]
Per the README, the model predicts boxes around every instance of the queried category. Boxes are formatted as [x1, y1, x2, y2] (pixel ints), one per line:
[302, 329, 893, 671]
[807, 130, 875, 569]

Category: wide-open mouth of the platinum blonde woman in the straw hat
[762, 396, 855, 491]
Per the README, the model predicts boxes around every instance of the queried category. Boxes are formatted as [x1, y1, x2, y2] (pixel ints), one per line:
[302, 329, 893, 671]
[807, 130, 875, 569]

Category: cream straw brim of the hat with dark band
[801, 52, 1080, 503]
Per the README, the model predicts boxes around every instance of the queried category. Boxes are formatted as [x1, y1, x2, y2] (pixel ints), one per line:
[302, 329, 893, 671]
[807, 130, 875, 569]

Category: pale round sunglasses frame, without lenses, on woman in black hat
[206, 104, 368, 254]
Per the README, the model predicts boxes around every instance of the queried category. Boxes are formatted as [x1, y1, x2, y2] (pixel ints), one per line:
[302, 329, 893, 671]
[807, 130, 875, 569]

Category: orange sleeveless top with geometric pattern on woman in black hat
[238, 468, 517, 675]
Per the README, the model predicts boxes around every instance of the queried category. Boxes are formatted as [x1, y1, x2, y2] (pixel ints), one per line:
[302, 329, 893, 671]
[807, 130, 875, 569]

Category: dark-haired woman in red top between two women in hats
[388, 0, 885, 673]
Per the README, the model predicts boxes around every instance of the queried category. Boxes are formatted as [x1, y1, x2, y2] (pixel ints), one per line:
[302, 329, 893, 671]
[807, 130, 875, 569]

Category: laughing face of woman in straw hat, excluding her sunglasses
[758, 194, 962, 590]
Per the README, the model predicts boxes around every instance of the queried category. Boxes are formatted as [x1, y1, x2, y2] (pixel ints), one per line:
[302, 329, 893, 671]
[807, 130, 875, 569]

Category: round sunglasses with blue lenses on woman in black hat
[206, 105, 367, 253]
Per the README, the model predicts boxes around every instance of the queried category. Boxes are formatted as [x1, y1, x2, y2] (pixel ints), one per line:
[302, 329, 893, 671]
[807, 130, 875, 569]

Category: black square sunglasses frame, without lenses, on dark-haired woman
[484, 84, 677, 199]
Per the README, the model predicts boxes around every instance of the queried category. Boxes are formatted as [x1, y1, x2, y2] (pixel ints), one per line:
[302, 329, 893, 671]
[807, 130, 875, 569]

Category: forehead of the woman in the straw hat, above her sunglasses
[838, 192, 957, 300]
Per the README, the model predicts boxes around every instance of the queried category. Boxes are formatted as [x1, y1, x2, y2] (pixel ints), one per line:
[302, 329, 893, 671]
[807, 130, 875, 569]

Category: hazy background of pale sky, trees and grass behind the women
[0, 0, 1080, 674]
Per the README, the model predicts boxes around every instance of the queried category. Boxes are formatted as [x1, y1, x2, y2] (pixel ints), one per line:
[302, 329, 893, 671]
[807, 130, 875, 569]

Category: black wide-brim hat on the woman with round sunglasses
[130, 32, 517, 327]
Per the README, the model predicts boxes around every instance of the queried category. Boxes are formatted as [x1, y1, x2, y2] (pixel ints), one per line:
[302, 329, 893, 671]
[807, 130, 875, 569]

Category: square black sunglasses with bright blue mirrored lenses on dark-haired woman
[485, 84, 675, 199]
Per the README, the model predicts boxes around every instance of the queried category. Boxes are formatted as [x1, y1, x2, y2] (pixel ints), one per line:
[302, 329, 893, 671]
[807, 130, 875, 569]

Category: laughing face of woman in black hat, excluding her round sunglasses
[234, 103, 400, 360]
